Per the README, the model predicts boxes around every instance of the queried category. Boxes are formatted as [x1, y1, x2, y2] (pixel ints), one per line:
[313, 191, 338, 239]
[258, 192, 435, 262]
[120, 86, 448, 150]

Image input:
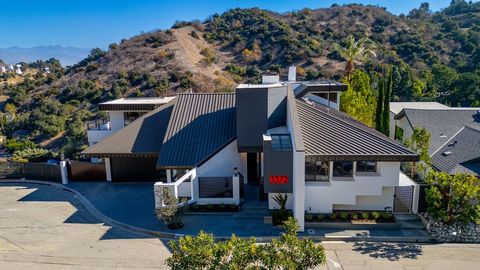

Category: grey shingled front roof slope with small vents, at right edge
[432, 125, 480, 176]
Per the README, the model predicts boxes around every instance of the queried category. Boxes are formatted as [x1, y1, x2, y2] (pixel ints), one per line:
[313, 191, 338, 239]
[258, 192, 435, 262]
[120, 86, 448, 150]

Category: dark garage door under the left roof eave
[110, 158, 166, 182]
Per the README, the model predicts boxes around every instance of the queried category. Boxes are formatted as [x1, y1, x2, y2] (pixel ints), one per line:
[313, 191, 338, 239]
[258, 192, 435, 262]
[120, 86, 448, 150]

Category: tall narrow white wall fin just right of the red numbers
[292, 152, 305, 232]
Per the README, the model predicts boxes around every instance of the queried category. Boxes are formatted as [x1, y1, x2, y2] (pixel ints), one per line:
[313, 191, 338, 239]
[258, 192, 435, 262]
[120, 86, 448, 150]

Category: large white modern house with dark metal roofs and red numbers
[83, 68, 419, 230]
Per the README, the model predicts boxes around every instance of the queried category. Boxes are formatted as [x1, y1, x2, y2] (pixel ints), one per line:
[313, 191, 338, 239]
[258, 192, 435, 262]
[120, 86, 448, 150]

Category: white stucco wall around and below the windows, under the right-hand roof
[305, 162, 400, 213]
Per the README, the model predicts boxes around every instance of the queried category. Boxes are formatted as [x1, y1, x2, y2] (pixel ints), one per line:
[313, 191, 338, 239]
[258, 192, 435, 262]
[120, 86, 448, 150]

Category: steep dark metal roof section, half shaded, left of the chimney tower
[157, 93, 236, 168]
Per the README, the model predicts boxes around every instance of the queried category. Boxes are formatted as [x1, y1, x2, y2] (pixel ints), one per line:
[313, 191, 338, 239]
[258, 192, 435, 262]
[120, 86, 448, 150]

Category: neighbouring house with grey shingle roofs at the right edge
[390, 102, 480, 176]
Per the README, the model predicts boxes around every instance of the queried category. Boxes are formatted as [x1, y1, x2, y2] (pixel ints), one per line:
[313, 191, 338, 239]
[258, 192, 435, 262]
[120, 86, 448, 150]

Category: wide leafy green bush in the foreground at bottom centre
[167, 217, 326, 270]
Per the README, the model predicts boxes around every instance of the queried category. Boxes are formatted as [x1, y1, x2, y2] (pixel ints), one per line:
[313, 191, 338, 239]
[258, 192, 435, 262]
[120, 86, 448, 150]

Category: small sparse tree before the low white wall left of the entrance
[156, 188, 186, 229]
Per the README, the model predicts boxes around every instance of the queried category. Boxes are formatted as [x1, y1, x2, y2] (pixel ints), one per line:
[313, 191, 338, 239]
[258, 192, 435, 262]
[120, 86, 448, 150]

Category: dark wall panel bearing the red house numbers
[263, 138, 293, 193]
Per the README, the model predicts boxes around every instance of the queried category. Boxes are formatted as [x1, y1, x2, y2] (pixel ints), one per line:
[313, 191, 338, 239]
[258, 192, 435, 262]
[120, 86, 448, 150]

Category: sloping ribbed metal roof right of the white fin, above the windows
[296, 99, 419, 161]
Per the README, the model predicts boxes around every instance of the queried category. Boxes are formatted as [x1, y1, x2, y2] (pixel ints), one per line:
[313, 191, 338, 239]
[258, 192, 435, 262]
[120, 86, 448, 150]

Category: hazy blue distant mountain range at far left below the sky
[0, 46, 90, 66]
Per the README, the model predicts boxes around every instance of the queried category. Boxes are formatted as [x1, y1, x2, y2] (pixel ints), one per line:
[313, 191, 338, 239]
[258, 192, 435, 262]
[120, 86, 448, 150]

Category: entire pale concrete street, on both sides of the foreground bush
[0, 183, 480, 270]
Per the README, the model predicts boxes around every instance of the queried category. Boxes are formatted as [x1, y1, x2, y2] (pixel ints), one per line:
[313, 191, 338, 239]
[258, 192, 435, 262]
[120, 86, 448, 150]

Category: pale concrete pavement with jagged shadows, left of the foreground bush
[0, 183, 169, 270]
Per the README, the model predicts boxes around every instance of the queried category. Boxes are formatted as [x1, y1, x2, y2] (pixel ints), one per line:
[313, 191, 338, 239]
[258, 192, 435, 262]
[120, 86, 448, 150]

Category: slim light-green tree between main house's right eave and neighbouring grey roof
[405, 127, 432, 178]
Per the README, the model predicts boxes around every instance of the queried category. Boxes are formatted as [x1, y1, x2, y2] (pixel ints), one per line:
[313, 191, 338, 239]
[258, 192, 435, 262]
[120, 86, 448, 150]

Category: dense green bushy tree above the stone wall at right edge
[426, 171, 480, 224]
